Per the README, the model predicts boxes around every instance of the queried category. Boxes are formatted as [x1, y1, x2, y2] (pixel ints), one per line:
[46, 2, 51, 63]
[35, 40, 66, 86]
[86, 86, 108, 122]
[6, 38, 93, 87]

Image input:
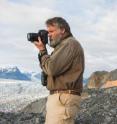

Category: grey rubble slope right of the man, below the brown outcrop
[76, 87, 117, 124]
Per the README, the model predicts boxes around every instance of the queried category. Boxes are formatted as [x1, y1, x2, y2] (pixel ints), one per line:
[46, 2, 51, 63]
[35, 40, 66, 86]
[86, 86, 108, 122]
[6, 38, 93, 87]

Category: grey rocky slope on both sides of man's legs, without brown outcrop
[0, 87, 117, 124]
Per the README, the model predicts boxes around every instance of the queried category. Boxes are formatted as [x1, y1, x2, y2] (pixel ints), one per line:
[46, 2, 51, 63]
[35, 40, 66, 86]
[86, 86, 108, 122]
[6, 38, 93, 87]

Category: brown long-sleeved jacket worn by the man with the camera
[41, 37, 84, 92]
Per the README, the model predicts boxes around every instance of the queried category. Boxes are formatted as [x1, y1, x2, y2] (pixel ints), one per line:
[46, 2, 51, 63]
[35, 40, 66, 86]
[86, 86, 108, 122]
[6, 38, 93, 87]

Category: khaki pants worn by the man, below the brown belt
[45, 93, 81, 124]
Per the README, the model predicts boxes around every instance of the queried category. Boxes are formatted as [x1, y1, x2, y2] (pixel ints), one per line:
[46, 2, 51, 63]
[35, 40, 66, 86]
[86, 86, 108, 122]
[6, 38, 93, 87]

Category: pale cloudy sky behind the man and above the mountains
[0, 0, 117, 77]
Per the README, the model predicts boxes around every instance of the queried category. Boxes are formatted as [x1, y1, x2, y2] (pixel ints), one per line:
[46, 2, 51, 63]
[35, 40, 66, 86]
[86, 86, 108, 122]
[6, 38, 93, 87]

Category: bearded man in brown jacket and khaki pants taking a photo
[34, 17, 84, 124]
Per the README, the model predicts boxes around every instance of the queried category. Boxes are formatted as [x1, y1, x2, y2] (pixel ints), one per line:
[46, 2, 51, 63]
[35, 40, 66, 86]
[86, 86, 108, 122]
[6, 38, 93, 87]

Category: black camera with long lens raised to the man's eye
[27, 29, 48, 44]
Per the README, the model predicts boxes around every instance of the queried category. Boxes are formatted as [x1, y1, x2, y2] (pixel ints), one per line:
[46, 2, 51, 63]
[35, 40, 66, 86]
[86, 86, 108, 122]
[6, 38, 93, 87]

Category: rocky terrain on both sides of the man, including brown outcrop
[0, 69, 117, 124]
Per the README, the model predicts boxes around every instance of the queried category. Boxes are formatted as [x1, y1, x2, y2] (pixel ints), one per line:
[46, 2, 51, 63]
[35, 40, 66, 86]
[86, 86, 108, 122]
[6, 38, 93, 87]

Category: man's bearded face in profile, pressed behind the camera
[47, 24, 64, 47]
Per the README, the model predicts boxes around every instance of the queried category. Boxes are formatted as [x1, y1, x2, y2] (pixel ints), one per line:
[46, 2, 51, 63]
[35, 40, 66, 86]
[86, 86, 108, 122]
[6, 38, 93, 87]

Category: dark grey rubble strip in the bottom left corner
[0, 113, 45, 124]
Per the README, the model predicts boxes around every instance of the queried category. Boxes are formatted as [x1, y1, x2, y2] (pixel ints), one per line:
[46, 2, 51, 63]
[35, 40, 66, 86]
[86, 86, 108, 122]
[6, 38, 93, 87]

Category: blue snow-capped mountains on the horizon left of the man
[0, 66, 40, 81]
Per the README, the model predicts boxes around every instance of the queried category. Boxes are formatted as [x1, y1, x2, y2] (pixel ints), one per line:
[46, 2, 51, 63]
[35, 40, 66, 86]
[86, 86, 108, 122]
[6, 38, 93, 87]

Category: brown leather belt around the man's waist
[50, 90, 81, 96]
